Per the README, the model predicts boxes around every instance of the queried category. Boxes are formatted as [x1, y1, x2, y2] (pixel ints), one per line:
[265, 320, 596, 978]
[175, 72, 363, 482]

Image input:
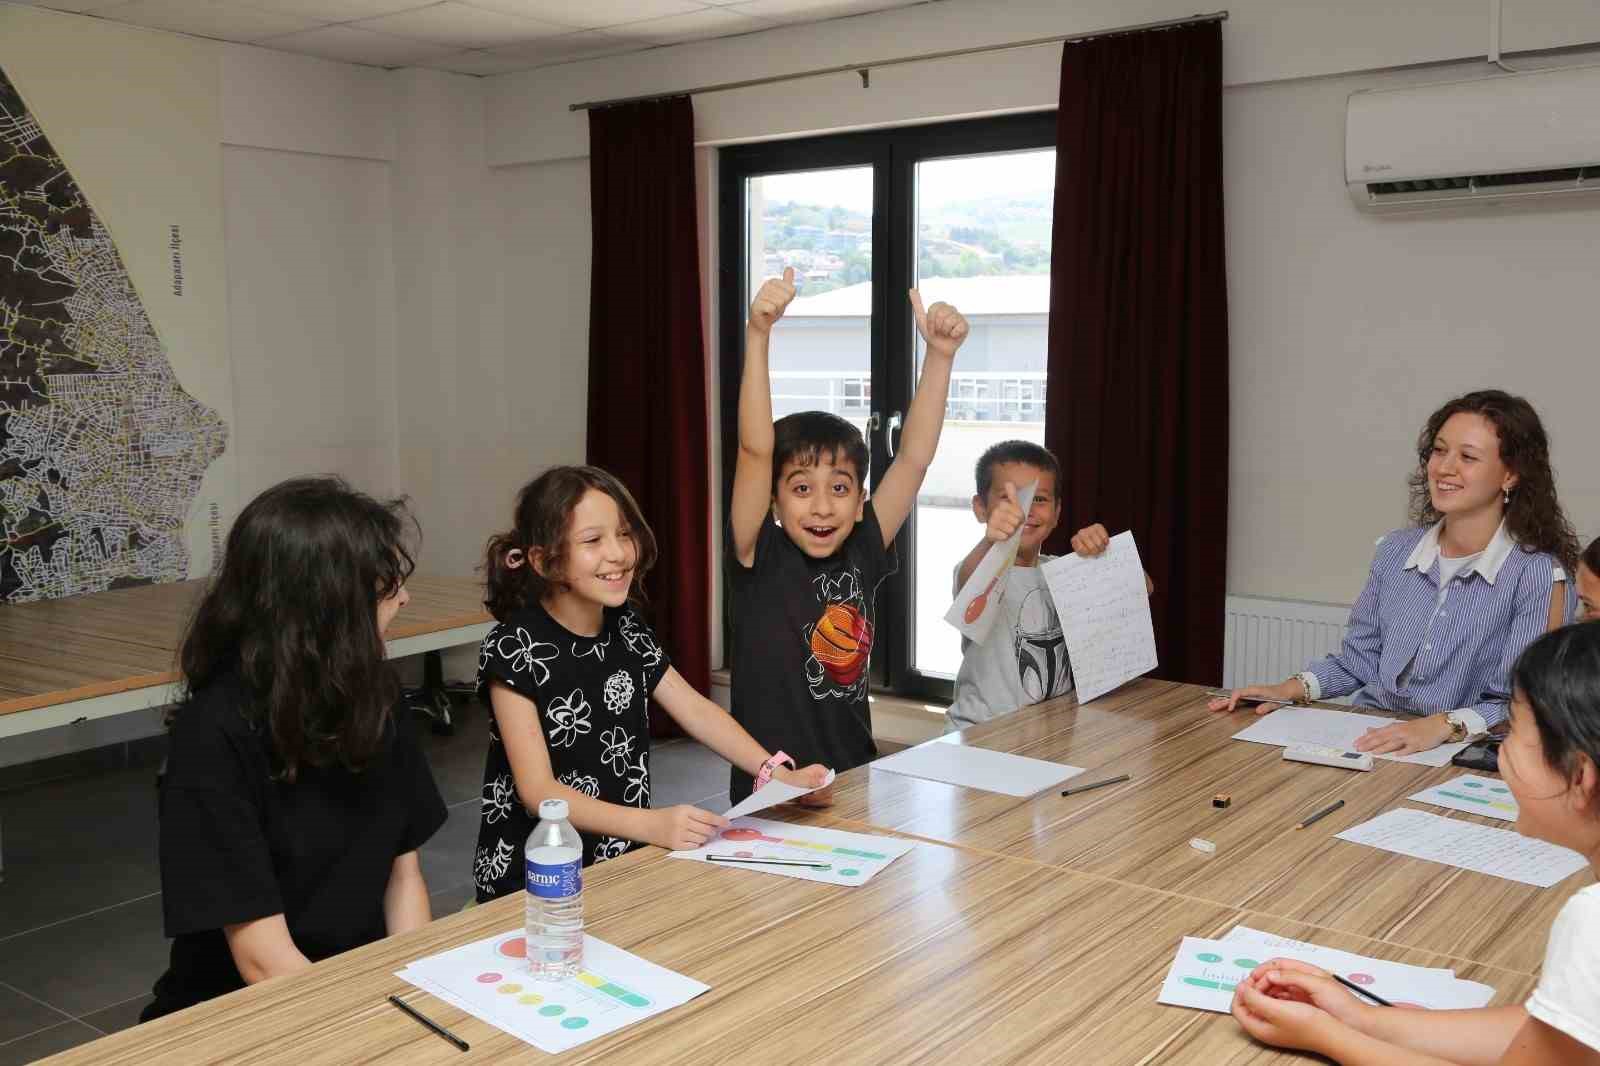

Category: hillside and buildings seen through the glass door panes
[746, 149, 1056, 677]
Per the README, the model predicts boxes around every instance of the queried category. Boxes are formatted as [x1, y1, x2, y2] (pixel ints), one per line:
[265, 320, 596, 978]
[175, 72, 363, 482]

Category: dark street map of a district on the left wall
[0, 62, 227, 603]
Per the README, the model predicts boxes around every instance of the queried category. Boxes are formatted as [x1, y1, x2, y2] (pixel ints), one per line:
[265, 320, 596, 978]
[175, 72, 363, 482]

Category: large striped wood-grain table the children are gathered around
[31, 682, 1592, 1066]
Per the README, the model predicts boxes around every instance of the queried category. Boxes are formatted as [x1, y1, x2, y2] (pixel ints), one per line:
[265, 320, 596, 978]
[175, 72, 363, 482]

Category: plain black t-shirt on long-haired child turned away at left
[142, 677, 446, 1020]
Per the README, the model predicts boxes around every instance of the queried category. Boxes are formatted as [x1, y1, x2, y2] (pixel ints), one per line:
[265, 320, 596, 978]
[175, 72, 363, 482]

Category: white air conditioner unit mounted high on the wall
[1344, 67, 1600, 211]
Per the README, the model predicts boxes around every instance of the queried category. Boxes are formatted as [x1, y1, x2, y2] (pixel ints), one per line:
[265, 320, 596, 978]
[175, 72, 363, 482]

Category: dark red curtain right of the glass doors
[1045, 22, 1229, 685]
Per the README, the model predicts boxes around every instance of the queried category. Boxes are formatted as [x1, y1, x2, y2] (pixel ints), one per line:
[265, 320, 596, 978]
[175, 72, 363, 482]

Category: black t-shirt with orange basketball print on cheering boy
[726, 501, 896, 802]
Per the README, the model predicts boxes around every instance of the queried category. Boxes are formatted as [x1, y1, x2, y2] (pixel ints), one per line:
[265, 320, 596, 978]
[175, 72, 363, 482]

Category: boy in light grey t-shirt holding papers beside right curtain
[946, 440, 1154, 730]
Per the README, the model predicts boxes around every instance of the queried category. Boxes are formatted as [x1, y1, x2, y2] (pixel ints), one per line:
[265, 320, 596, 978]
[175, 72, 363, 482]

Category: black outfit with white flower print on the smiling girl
[472, 603, 672, 903]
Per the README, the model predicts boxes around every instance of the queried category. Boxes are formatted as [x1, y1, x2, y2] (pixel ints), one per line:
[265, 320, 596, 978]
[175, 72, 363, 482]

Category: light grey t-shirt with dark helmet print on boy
[946, 554, 1072, 730]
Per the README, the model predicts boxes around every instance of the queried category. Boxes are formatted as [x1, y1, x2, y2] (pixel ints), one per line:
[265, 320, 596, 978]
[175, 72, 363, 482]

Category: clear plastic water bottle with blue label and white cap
[523, 800, 584, 981]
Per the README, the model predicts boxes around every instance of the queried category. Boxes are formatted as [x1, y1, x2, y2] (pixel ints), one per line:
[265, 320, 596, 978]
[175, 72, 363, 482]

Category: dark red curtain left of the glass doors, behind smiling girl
[589, 96, 712, 731]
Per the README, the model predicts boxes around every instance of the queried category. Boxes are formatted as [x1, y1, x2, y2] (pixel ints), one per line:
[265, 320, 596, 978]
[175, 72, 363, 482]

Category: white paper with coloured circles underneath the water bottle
[395, 932, 710, 1055]
